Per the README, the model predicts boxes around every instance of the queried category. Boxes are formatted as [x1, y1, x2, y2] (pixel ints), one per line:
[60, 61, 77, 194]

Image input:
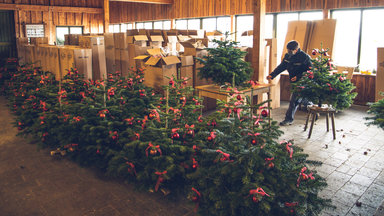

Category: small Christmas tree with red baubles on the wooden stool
[292, 49, 357, 110]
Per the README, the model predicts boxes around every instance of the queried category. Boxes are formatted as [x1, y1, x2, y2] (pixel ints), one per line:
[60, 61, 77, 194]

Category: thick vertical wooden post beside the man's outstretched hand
[252, 0, 267, 82]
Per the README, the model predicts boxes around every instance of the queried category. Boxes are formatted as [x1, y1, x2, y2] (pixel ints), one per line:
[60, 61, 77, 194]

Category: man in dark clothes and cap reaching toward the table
[267, 40, 312, 126]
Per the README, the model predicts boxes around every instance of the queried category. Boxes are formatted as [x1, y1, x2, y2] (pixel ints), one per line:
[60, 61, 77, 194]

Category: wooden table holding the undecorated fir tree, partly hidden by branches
[195, 84, 273, 120]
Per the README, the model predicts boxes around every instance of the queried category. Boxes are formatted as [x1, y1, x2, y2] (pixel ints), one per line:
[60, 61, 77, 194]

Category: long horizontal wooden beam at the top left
[0, 3, 104, 14]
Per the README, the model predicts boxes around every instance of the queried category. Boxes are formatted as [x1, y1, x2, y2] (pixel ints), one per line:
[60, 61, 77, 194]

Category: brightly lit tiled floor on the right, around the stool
[273, 103, 384, 216]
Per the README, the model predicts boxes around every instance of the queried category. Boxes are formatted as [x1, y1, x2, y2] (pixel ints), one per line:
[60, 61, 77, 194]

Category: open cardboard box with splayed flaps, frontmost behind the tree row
[135, 49, 180, 90]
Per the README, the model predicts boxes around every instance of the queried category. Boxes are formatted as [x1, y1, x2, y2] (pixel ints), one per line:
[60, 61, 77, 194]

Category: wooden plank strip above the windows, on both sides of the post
[110, 0, 384, 23]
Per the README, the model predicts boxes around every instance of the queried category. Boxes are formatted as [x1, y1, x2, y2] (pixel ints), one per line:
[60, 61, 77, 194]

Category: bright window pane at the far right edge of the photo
[360, 9, 384, 70]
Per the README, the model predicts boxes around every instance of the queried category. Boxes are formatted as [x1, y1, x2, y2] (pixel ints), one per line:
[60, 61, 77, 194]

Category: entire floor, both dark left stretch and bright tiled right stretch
[0, 97, 384, 216]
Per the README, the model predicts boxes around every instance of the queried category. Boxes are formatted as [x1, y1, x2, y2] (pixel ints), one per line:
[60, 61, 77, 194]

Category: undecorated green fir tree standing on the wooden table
[197, 32, 252, 86]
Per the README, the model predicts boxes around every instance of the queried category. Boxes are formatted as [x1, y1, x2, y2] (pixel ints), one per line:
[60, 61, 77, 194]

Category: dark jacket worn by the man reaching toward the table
[270, 49, 312, 82]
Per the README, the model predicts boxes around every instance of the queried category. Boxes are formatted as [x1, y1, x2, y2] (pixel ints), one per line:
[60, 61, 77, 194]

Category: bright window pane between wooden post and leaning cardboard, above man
[276, 13, 299, 60]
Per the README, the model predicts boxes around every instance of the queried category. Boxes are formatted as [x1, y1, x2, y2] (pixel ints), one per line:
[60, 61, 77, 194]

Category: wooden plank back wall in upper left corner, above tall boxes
[0, 0, 104, 43]
